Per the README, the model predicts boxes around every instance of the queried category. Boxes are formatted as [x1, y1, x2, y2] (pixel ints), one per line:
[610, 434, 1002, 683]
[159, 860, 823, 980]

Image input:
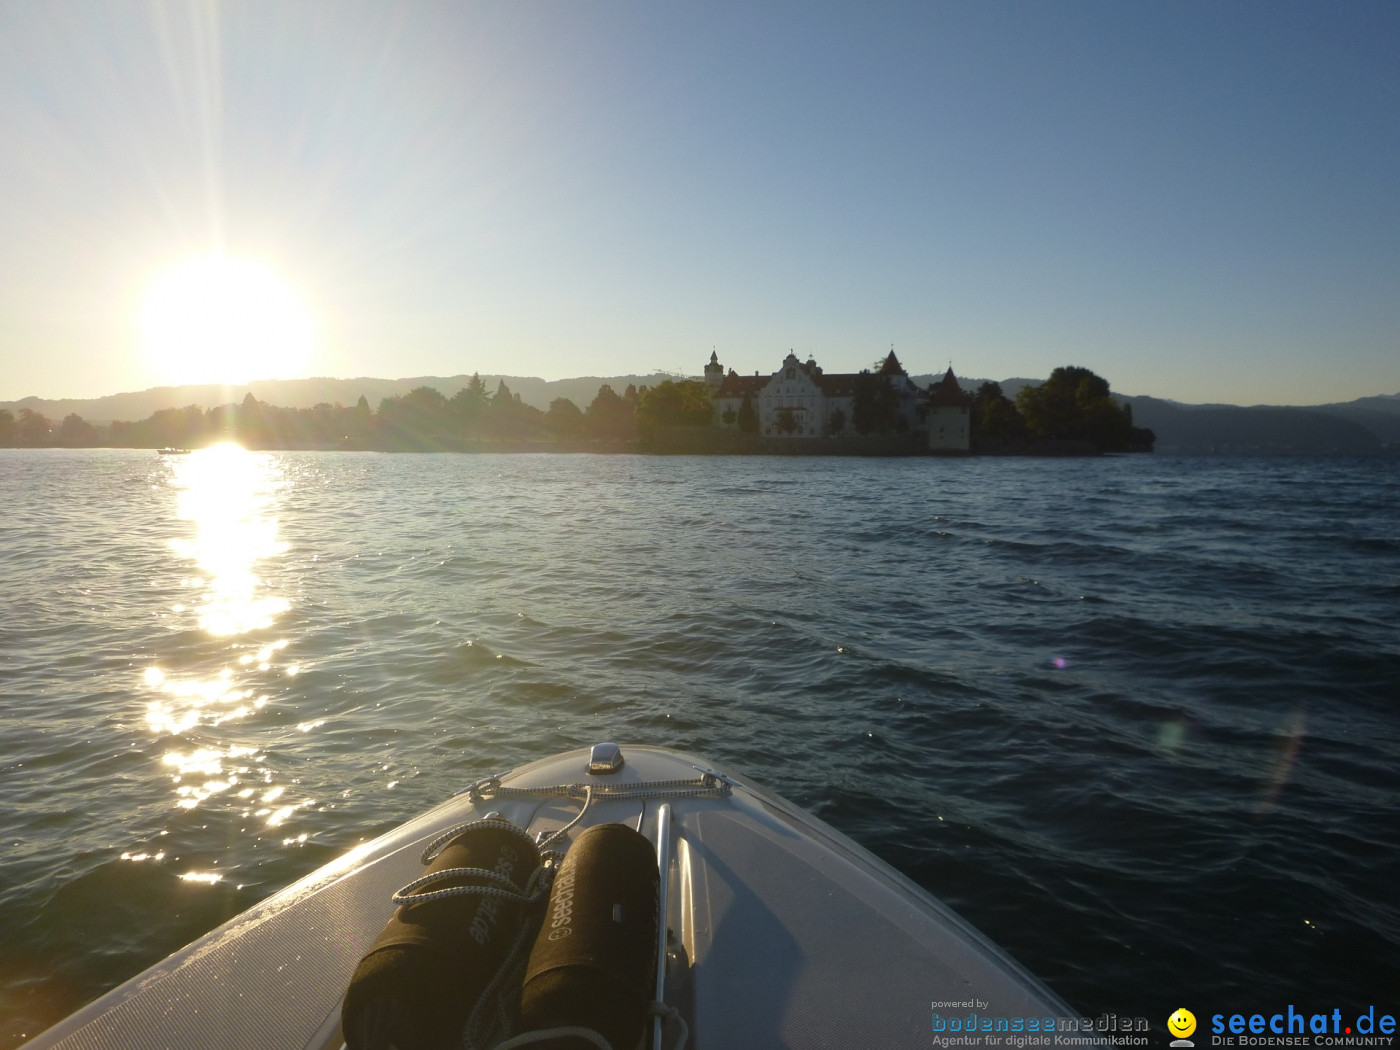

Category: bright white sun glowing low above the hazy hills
[140, 255, 315, 385]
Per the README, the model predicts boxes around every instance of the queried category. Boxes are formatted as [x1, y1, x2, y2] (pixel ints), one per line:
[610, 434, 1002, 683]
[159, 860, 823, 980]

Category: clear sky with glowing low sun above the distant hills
[0, 0, 1400, 405]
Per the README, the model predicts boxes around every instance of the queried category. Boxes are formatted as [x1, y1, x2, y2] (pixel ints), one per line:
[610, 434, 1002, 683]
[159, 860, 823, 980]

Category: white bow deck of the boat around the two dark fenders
[19, 746, 1092, 1050]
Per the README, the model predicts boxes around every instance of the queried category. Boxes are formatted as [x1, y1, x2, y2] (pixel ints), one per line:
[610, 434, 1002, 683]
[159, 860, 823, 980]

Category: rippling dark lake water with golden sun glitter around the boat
[0, 449, 1400, 1047]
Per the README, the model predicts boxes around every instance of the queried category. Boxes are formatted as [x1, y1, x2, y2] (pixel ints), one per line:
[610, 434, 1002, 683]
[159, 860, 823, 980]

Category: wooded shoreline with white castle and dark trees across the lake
[0, 350, 1155, 456]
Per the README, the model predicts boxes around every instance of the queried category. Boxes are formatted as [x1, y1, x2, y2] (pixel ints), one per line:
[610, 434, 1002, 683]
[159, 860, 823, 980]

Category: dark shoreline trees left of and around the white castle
[0, 367, 1154, 452]
